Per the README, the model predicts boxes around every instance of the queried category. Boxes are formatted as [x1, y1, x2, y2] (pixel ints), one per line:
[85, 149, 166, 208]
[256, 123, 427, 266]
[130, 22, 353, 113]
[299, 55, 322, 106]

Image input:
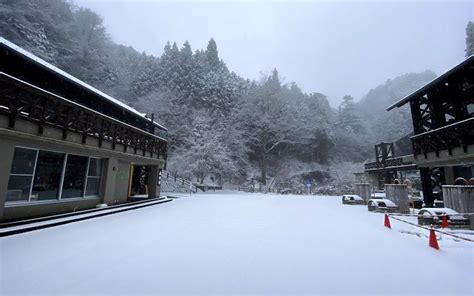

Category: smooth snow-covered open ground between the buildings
[0, 193, 474, 295]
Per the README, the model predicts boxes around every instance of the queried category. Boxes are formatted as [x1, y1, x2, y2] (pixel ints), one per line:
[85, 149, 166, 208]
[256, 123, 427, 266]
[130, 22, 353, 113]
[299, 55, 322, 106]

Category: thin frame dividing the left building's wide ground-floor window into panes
[5, 145, 104, 206]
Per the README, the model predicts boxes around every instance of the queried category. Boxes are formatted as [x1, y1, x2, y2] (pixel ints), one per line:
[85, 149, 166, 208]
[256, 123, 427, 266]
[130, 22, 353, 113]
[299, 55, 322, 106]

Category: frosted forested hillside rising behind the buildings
[0, 0, 435, 184]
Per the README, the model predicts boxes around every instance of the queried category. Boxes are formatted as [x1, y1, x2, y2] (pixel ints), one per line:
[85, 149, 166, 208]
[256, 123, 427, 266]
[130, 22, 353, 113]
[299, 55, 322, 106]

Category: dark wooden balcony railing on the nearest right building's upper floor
[411, 117, 474, 158]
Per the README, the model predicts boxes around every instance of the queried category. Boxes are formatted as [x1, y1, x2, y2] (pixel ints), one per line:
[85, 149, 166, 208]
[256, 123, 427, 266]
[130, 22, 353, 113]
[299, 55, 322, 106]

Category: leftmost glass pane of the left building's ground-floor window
[6, 148, 38, 201]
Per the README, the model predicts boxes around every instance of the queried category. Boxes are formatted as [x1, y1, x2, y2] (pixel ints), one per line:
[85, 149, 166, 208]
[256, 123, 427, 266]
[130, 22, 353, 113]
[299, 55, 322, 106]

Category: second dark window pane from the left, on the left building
[31, 151, 64, 200]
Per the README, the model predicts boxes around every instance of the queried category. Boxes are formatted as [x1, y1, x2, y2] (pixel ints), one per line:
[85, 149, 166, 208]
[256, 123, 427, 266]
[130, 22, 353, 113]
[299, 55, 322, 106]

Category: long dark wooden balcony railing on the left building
[0, 72, 167, 158]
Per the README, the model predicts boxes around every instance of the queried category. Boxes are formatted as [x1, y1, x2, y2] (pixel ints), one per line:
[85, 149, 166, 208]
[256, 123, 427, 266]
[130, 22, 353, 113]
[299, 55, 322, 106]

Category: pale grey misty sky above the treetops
[74, 0, 474, 106]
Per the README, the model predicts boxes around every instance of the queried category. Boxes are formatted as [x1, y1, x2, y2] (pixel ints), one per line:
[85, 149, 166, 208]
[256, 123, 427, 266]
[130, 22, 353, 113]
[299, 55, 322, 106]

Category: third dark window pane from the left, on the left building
[61, 155, 87, 198]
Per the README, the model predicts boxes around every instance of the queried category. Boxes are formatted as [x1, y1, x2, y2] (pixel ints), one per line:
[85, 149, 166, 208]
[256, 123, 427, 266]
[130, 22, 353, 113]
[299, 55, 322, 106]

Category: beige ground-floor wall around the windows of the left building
[0, 116, 164, 222]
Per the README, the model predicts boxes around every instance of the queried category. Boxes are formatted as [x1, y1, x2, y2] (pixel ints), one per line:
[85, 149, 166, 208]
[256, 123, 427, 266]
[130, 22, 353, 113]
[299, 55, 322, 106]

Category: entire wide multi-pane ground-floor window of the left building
[6, 147, 102, 202]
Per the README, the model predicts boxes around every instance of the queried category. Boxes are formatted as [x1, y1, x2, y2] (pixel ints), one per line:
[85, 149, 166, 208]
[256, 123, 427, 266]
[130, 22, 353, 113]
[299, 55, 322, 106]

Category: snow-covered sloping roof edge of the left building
[0, 37, 168, 130]
